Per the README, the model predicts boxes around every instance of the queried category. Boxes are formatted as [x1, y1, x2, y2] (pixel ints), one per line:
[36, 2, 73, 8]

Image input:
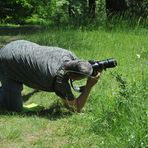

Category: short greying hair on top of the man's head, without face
[65, 60, 93, 76]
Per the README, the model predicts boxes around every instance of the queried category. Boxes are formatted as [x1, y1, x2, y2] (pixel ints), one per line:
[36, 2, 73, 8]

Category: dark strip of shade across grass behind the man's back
[0, 25, 42, 36]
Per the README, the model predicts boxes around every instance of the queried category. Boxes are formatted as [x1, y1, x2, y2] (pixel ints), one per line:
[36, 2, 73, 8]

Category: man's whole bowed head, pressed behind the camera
[65, 60, 93, 80]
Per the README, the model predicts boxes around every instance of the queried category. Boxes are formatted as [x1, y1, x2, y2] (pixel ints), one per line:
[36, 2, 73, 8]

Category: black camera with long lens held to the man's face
[89, 58, 117, 76]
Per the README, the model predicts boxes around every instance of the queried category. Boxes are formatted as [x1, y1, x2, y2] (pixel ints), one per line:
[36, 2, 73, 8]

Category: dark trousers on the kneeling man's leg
[0, 80, 23, 112]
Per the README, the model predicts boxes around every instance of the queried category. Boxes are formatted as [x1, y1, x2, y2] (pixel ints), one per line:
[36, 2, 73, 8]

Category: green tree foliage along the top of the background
[0, 0, 148, 24]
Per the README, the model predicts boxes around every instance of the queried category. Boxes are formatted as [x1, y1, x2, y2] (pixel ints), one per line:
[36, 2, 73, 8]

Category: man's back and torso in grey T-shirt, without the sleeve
[0, 40, 76, 91]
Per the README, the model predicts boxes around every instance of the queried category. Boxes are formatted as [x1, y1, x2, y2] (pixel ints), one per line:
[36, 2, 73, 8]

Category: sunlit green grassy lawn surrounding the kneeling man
[0, 28, 148, 148]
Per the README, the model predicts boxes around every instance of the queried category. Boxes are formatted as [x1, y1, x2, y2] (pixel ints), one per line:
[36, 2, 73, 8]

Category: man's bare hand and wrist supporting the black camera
[86, 72, 101, 87]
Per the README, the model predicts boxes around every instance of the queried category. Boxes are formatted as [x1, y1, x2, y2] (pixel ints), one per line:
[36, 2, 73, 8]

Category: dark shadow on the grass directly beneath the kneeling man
[0, 90, 73, 120]
